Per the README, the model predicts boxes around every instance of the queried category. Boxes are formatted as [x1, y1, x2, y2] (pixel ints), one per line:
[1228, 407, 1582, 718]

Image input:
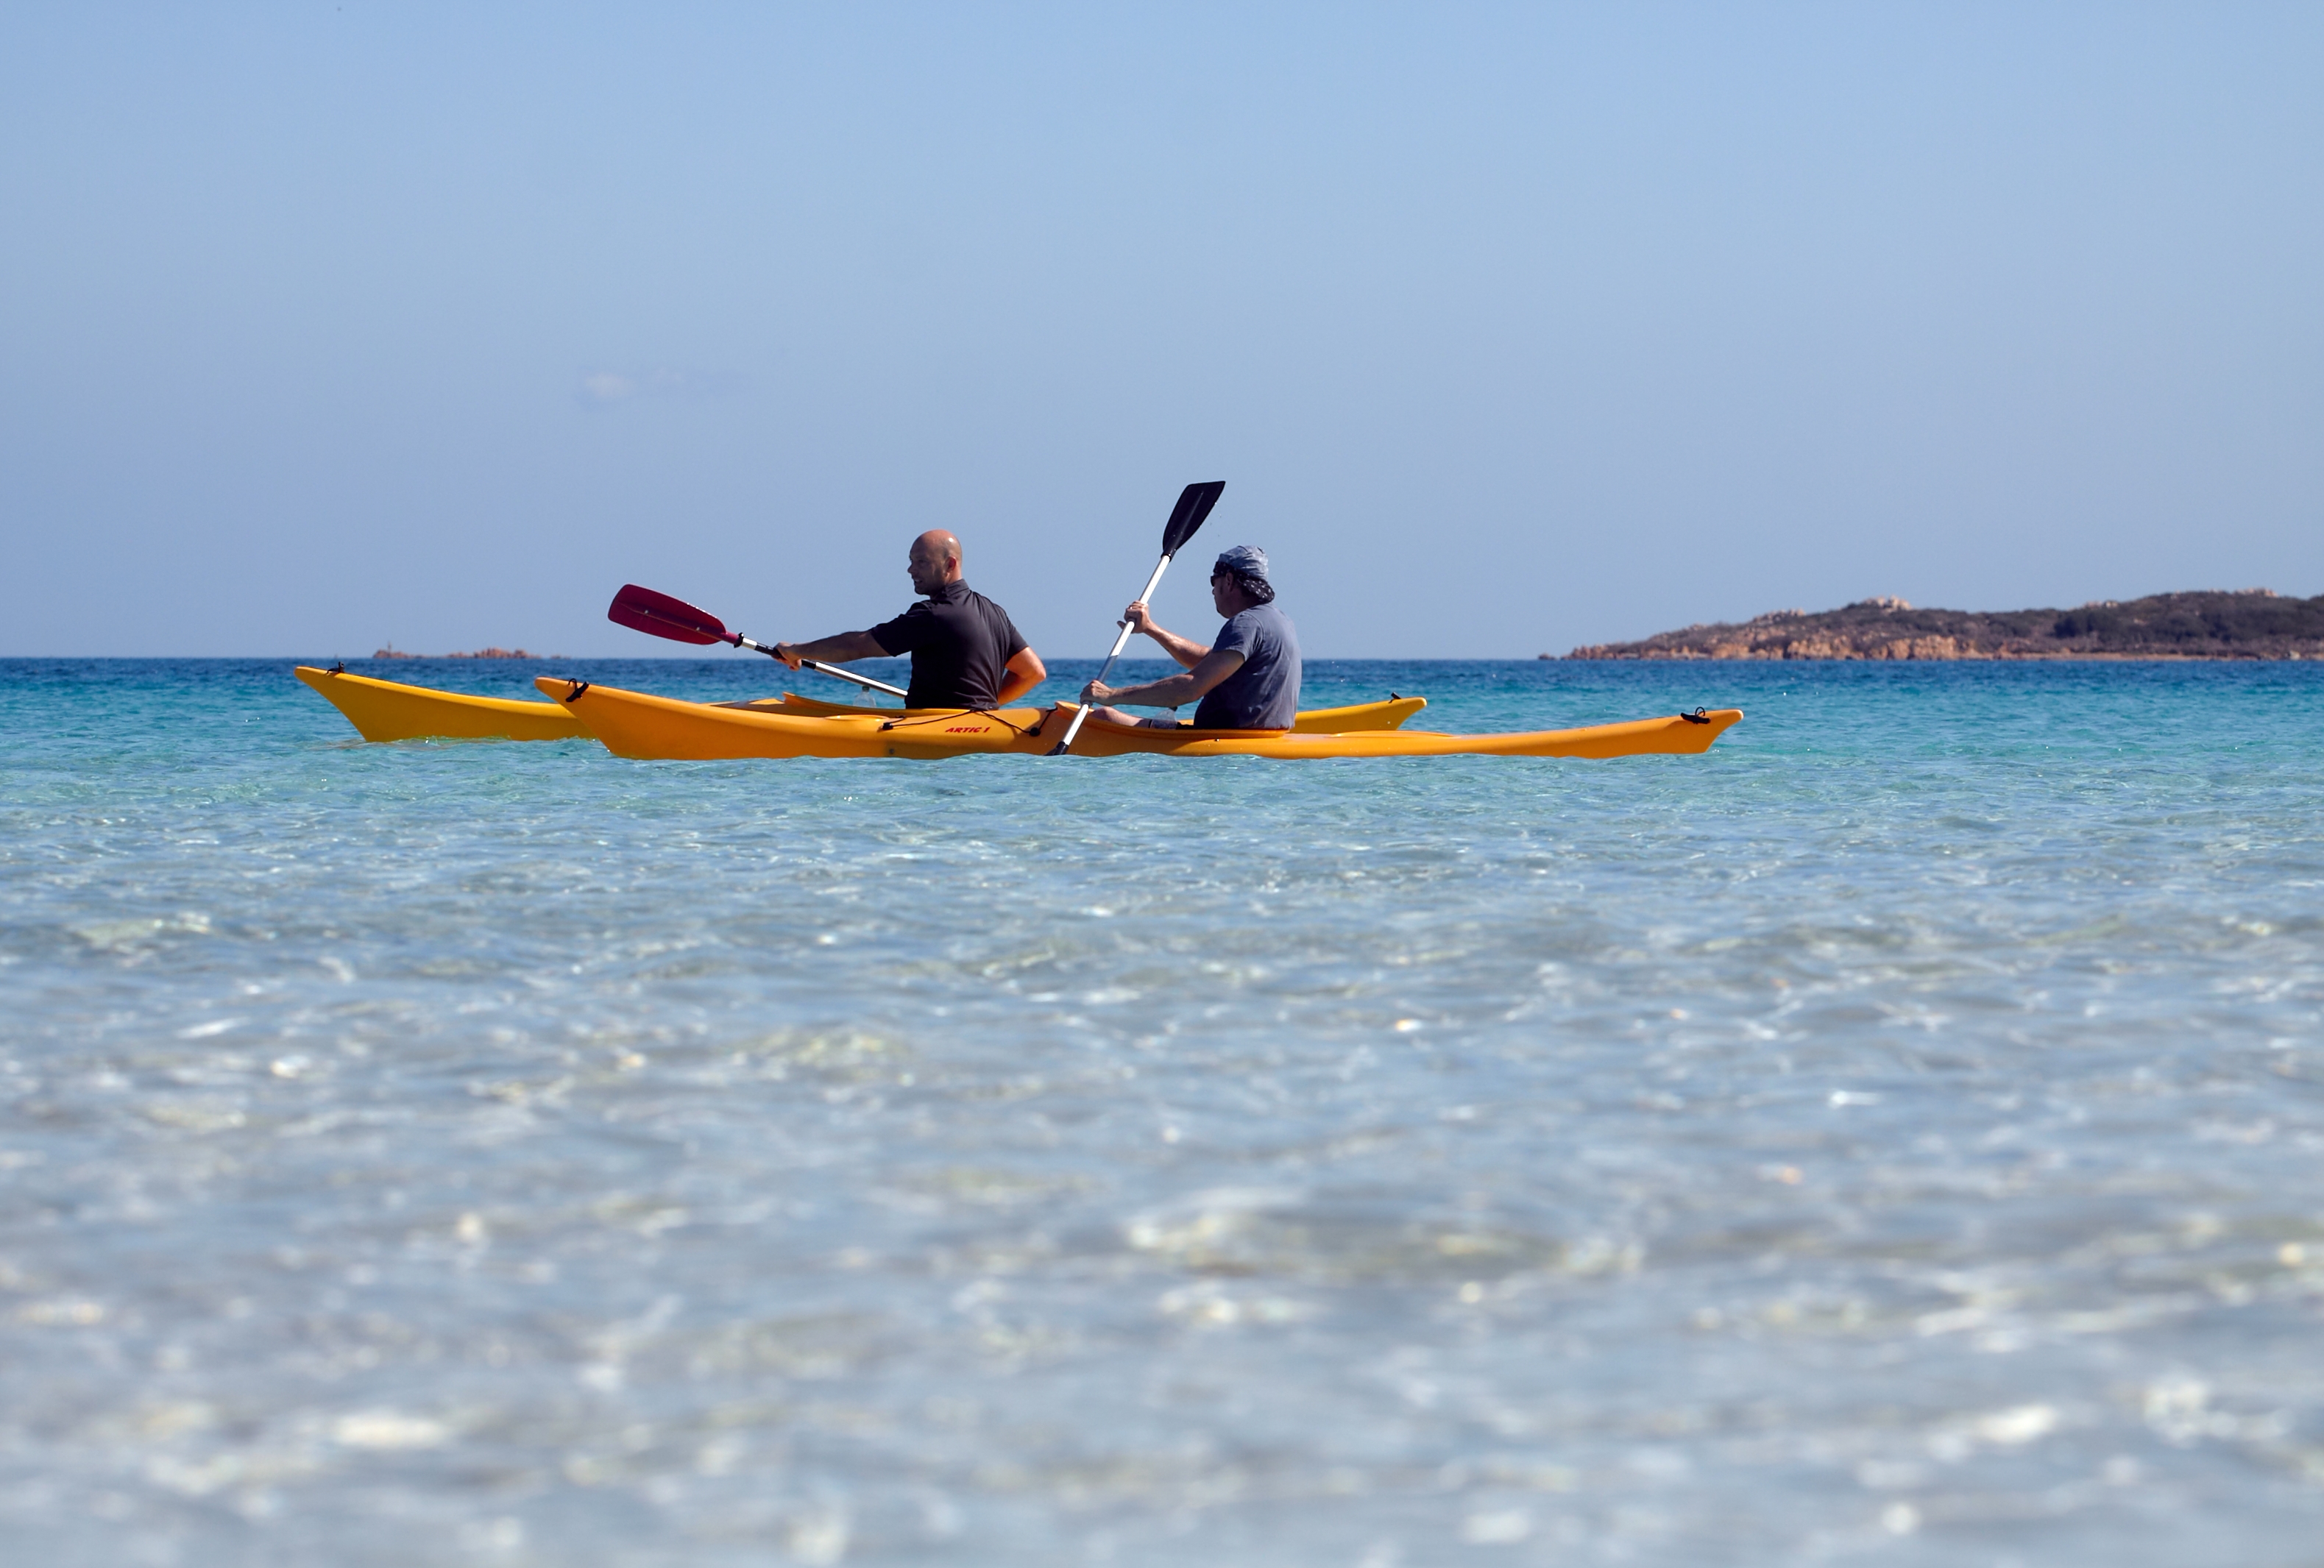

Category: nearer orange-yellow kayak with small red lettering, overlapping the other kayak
[534, 676, 1743, 759]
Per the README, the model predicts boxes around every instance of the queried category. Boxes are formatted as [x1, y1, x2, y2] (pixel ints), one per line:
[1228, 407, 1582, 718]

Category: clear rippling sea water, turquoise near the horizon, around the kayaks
[0, 657, 2324, 1568]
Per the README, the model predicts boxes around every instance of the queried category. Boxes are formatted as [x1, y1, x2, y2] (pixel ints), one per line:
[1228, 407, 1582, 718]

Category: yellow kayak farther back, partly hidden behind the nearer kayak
[293, 664, 1429, 741]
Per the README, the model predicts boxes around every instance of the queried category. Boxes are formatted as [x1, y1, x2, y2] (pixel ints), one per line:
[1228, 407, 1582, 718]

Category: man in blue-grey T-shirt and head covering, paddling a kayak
[1080, 544, 1299, 729]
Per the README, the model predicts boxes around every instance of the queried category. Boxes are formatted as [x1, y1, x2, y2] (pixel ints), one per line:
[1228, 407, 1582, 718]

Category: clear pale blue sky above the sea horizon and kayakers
[0, 0, 2324, 657]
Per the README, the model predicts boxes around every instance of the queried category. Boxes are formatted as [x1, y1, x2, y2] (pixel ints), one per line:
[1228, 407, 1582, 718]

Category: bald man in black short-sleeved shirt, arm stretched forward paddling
[774, 528, 1048, 709]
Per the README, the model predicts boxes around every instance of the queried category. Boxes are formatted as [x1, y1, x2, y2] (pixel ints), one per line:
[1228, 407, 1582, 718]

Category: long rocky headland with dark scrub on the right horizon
[1541, 588, 2324, 660]
